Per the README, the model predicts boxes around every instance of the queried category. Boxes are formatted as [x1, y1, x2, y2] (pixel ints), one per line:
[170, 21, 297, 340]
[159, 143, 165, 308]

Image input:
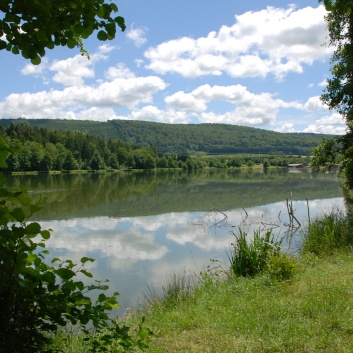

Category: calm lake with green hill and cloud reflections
[6, 169, 344, 314]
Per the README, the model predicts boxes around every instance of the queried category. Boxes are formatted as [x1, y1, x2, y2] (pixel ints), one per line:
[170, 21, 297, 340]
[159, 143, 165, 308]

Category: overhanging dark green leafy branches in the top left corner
[0, 0, 126, 64]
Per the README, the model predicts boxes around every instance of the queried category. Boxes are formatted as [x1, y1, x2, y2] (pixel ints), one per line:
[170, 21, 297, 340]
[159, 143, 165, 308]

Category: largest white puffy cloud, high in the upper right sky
[144, 6, 331, 80]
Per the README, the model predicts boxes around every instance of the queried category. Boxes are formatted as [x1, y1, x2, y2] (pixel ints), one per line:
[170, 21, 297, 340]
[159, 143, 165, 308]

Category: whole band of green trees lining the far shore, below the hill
[0, 124, 310, 172]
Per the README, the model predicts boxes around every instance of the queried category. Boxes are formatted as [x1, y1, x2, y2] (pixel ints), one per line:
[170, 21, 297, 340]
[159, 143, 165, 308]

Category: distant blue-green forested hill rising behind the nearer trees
[0, 119, 333, 155]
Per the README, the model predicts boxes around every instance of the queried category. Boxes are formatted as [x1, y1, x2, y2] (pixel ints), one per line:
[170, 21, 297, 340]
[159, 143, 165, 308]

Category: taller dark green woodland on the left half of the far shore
[0, 124, 195, 172]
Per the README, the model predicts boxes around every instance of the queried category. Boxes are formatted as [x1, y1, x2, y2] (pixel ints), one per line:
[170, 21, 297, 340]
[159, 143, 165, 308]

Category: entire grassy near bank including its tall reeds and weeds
[126, 212, 353, 353]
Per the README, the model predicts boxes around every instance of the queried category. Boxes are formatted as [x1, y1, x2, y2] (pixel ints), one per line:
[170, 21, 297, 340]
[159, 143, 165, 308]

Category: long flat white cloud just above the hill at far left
[0, 76, 166, 120]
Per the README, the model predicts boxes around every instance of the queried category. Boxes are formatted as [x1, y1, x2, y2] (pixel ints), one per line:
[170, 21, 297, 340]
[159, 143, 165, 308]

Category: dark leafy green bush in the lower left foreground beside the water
[0, 139, 152, 353]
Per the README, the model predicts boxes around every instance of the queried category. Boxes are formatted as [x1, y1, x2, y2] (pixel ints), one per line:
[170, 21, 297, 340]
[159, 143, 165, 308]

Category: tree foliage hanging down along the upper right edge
[314, 0, 353, 189]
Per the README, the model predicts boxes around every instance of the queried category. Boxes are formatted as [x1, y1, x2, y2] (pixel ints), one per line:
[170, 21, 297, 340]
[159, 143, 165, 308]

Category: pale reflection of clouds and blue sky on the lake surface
[40, 198, 344, 308]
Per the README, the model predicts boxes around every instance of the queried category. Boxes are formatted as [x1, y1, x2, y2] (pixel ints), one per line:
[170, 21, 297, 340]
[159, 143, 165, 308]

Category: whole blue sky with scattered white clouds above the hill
[0, 0, 345, 134]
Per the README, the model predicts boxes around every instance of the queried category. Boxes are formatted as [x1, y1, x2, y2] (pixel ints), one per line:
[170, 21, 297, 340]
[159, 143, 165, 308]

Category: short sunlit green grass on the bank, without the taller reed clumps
[142, 251, 353, 353]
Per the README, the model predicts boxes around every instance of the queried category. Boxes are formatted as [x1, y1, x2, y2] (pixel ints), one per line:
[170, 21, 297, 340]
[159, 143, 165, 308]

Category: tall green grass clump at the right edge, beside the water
[302, 210, 353, 255]
